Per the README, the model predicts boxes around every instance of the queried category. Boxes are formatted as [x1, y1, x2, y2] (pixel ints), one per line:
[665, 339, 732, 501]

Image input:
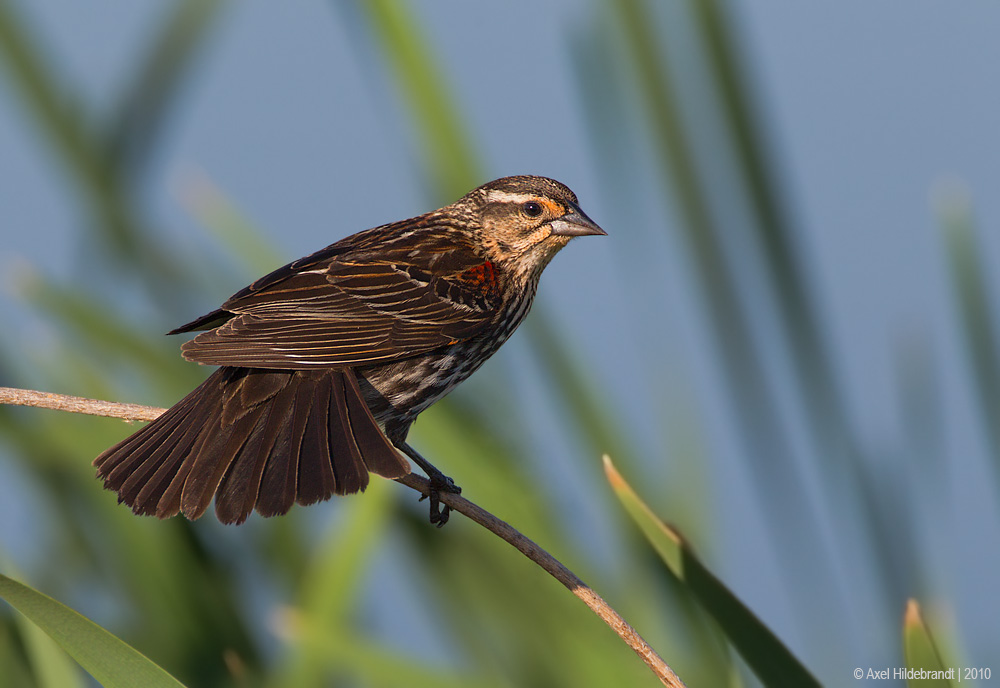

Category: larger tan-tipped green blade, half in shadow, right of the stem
[604, 456, 819, 687]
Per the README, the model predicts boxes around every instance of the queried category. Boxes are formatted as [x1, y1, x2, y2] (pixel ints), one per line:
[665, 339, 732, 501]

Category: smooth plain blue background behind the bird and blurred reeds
[0, 0, 1000, 675]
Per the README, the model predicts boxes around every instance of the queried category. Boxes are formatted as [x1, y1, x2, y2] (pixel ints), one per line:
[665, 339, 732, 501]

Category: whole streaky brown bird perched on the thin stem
[94, 176, 605, 524]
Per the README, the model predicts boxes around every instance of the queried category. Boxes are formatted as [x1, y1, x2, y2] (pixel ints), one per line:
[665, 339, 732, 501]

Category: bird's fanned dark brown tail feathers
[94, 367, 410, 523]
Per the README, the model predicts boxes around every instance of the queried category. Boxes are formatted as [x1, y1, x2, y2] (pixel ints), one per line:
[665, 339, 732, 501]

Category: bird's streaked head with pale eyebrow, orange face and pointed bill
[455, 176, 607, 280]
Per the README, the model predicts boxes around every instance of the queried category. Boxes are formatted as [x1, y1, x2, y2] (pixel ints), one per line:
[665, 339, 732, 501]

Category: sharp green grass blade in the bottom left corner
[0, 574, 183, 688]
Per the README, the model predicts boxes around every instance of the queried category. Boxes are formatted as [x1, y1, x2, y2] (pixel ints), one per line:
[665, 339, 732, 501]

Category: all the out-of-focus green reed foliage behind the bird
[0, 0, 1000, 687]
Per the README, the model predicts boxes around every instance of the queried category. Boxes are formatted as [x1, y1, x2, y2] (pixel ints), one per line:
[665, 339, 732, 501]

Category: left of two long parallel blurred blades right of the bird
[608, 0, 864, 647]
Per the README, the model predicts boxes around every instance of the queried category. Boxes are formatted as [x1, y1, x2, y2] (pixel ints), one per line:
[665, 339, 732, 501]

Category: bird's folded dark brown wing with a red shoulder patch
[175, 226, 499, 369]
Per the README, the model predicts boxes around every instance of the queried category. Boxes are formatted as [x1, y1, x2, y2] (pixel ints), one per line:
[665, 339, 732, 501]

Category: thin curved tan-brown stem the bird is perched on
[0, 387, 684, 688]
